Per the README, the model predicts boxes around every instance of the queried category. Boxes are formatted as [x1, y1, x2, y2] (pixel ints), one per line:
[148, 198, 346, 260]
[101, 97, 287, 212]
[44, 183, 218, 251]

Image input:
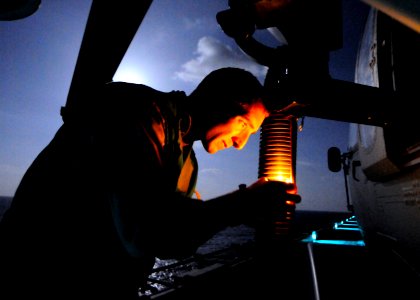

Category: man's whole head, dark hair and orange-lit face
[189, 67, 269, 153]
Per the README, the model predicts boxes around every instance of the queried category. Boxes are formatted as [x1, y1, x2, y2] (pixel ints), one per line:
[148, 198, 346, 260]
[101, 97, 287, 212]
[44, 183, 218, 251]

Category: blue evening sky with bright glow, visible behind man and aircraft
[0, 0, 367, 211]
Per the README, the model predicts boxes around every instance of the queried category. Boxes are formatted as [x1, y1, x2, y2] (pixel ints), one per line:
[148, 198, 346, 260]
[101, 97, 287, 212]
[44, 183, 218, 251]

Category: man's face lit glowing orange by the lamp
[201, 103, 268, 154]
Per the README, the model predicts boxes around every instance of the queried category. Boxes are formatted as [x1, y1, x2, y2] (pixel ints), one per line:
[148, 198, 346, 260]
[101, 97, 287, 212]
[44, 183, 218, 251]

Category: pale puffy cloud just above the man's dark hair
[175, 36, 267, 83]
